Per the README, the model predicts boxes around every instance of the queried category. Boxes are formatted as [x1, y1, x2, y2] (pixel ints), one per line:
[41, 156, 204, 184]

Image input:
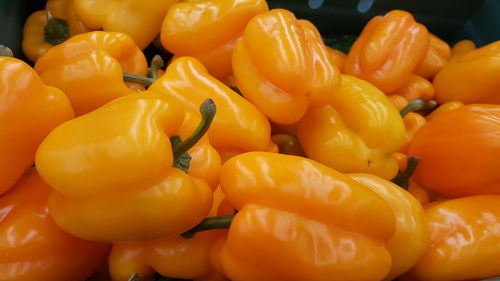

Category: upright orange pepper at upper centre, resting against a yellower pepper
[233, 9, 340, 124]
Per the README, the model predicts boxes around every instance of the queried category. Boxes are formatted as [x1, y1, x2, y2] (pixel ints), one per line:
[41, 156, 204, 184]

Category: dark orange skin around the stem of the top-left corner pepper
[22, 0, 90, 62]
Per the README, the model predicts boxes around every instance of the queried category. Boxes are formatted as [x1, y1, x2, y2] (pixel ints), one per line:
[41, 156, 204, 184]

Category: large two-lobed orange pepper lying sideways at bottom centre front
[220, 152, 395, 281]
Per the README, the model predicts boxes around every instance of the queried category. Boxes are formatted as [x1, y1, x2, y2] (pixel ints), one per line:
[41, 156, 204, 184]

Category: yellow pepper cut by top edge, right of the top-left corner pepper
[74, 0, 177, 50]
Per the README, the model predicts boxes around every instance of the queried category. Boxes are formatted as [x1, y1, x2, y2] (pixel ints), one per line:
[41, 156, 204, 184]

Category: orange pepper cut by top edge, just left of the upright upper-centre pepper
[161, 0, 269, 78]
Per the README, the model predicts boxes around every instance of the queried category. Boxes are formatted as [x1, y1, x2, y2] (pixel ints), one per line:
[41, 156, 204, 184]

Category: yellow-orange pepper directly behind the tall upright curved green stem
[149, 57, 271, 151]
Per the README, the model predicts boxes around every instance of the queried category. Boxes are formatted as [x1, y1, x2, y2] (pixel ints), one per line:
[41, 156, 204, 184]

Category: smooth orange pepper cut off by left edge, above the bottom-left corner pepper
[0, 56, 73, 194]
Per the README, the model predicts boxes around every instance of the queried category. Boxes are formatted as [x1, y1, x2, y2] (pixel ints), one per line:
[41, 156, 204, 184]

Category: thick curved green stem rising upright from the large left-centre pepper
[173, 99, 217, 162]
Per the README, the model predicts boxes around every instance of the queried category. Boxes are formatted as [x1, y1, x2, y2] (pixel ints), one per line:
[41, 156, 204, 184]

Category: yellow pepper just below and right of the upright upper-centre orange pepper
[297, 75, 405, 179]
